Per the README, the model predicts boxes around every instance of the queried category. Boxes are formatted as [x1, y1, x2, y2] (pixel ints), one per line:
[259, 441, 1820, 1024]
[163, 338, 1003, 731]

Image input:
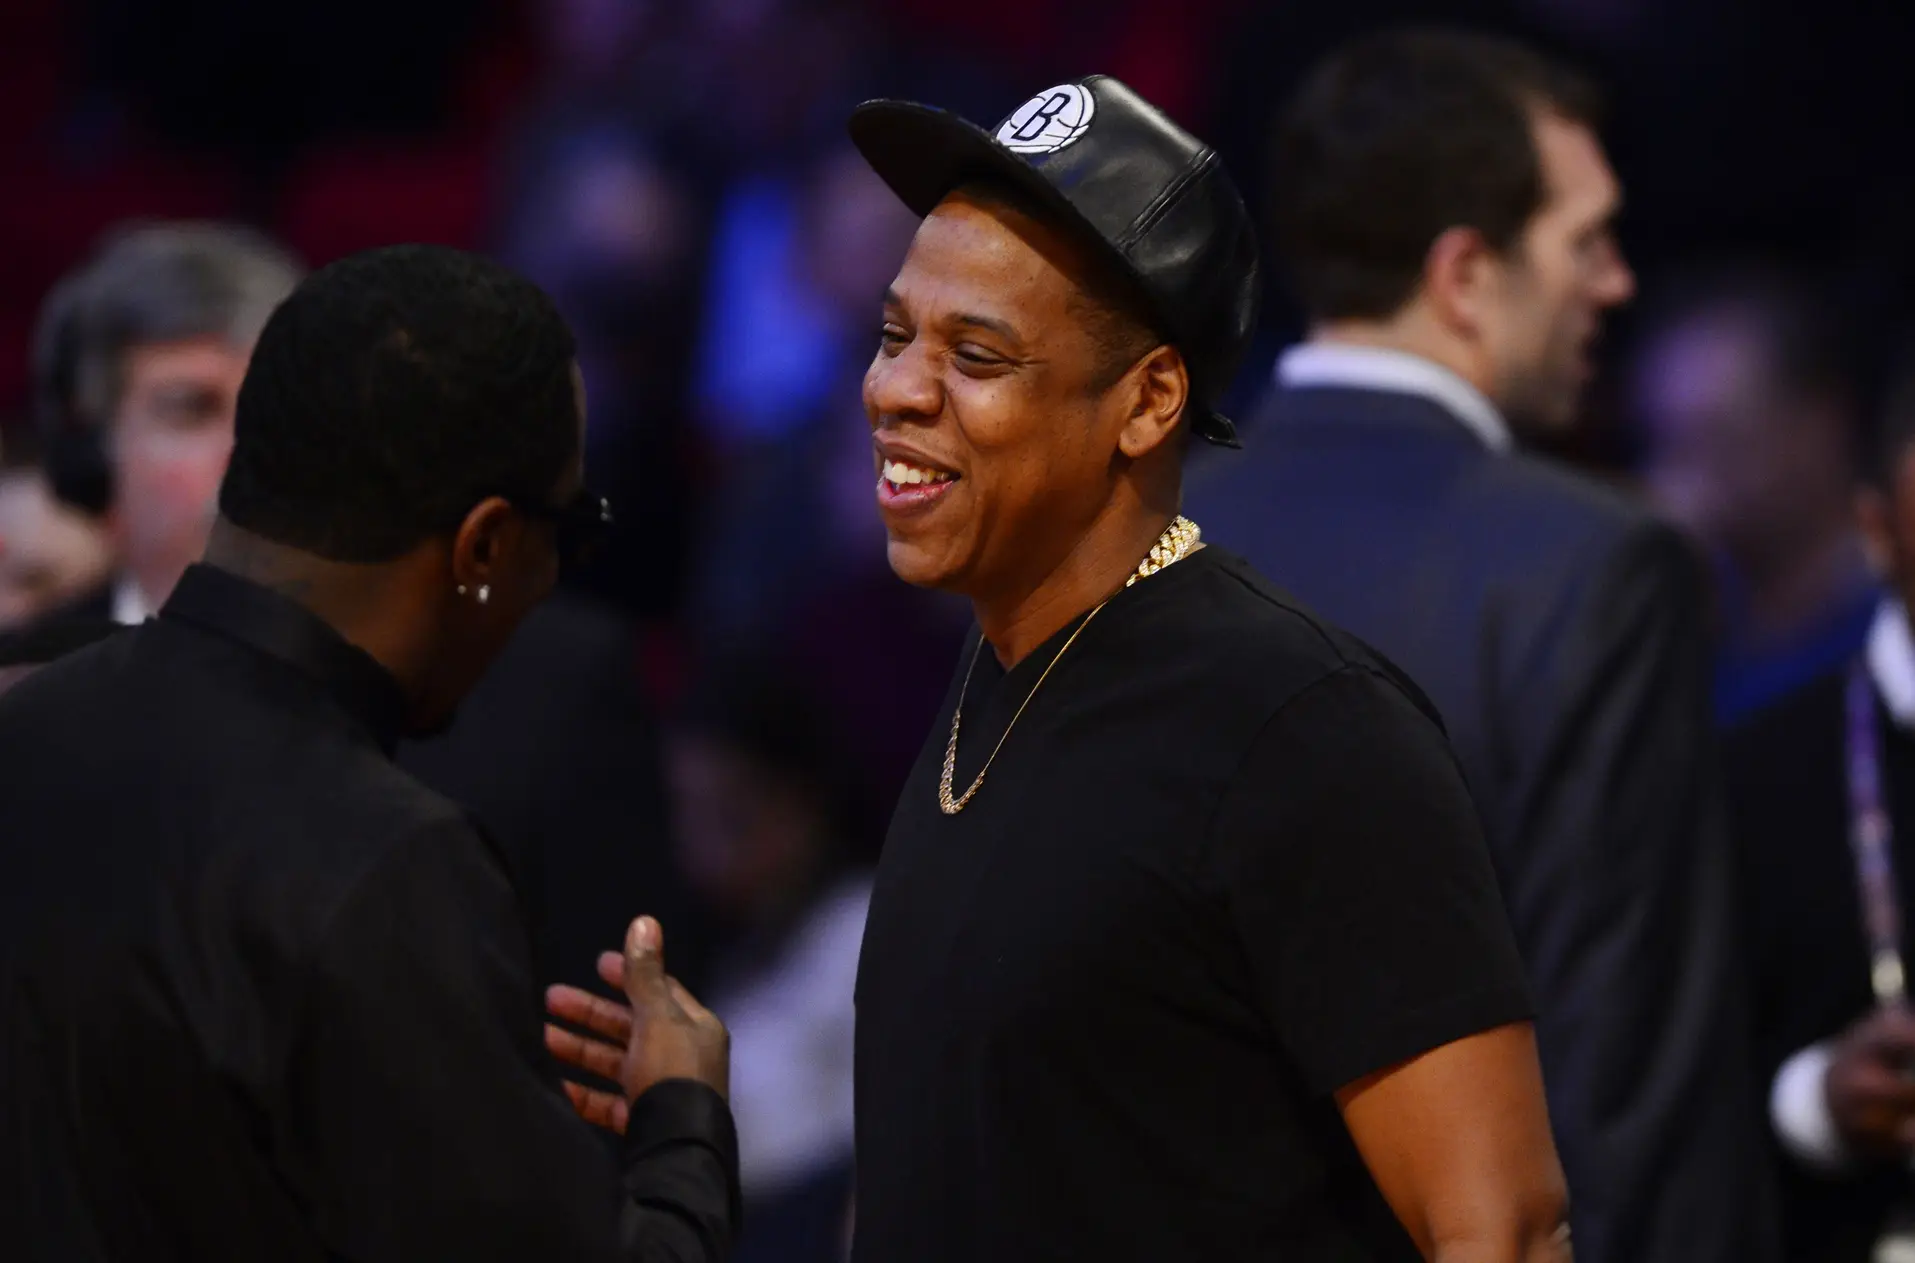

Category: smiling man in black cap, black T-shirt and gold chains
[551, 77, 1568, 1263]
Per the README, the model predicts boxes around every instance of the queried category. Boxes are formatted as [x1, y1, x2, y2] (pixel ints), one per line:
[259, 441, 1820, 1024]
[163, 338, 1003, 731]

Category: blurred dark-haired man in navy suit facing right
[1189, 33, 1769, 1263]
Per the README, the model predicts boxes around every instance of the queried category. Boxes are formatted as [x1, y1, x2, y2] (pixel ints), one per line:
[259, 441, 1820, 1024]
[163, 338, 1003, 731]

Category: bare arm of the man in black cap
[1337, 1024, 1570, 1263]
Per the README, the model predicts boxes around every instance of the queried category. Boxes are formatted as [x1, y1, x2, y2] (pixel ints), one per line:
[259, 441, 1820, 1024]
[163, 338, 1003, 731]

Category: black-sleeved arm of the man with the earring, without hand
[274, 825, 739, 1263]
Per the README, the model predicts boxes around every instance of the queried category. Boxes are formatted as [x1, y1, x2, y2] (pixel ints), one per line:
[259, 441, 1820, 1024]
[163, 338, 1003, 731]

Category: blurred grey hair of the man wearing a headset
[33, 222, 304, 432]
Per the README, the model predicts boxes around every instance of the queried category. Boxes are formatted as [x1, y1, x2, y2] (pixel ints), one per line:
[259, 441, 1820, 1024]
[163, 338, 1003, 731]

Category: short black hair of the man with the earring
[220, 245, 578, 563]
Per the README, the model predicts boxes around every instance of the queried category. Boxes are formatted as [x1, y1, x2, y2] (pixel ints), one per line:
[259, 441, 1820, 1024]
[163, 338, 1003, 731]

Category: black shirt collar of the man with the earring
[159, 565, 406, 754]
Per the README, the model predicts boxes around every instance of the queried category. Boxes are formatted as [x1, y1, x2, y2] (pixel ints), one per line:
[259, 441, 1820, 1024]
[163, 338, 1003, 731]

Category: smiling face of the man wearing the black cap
[864, 193, 1182, 599]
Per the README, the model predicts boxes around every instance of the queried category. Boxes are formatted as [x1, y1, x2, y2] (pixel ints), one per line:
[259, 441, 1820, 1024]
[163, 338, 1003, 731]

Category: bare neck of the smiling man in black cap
[971, 503, 1176, 670]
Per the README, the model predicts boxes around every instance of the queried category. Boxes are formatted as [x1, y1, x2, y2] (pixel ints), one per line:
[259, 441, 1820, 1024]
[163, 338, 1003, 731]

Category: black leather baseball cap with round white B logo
[850, 75, 1262, 448]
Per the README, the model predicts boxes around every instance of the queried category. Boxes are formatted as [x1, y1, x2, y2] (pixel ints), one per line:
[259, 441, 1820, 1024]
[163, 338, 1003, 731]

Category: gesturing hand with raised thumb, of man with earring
[546, 917, 732, 1135]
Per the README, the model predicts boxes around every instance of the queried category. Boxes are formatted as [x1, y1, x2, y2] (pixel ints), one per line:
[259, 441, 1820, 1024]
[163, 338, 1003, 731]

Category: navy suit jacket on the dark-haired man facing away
[1187, 387, 1773, 1263]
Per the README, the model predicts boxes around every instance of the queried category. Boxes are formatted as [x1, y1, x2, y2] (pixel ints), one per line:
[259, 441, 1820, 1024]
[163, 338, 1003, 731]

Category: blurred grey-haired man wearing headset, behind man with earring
[0, 222, 703, 984]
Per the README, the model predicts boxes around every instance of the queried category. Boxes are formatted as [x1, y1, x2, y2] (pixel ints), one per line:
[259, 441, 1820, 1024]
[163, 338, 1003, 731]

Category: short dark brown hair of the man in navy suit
[1272, 29, 1601, 320]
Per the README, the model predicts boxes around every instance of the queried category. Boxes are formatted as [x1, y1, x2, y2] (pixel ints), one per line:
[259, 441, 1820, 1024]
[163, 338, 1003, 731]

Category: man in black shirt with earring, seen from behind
[0, 247, 737, 1261]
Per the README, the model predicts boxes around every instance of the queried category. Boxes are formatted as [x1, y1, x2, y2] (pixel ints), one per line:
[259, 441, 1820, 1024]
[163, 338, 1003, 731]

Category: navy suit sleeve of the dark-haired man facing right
[1490, 524, 1773, 1263]
